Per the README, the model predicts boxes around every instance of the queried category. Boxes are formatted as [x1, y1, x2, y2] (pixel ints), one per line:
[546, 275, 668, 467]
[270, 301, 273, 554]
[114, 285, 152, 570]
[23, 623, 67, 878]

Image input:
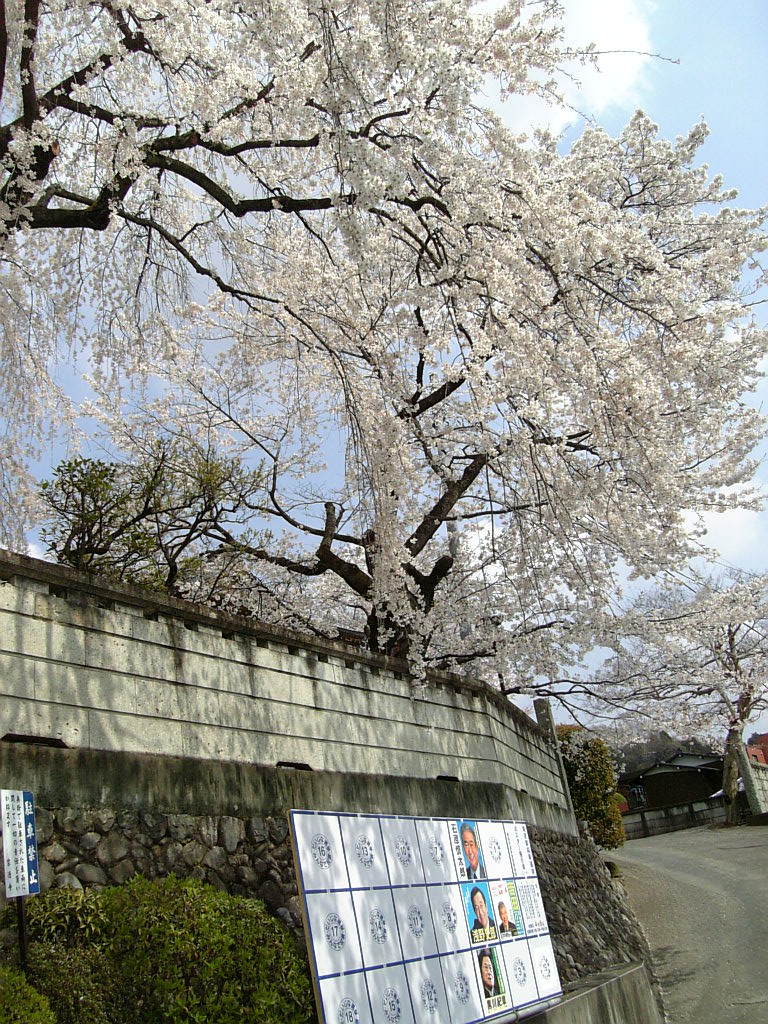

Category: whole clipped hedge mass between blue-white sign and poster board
[24, 877, 314, 1024]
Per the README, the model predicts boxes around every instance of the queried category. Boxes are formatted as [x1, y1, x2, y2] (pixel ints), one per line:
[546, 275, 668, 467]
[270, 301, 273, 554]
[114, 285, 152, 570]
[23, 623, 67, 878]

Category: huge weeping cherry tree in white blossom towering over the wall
[0, 0, 766, 689]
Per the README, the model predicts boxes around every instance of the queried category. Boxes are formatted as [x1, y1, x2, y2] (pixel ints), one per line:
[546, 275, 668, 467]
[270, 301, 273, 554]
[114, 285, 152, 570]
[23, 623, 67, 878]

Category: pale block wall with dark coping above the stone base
[0, 554, 577, 835]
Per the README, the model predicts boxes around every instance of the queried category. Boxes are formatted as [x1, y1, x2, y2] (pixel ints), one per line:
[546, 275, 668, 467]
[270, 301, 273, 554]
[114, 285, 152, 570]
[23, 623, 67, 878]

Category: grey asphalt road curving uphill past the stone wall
[607, 825, 768, 1024]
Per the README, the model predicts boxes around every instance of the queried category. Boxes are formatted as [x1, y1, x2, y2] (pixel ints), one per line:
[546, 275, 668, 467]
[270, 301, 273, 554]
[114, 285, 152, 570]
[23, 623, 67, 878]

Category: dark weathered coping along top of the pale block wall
[0, 548, 549, 742]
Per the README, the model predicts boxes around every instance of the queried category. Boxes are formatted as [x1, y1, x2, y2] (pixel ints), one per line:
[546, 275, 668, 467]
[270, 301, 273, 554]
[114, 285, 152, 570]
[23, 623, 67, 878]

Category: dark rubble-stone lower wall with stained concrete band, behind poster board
[0, 741, 663, 999]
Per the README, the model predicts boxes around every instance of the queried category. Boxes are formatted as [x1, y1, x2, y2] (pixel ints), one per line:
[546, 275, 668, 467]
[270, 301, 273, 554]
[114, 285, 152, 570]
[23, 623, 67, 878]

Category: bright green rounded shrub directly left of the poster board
[102, 877, 314, 1024]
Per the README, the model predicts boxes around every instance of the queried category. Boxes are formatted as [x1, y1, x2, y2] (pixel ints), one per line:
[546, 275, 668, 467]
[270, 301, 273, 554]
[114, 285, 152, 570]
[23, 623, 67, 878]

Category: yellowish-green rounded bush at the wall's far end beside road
[557, 725, 626, 850]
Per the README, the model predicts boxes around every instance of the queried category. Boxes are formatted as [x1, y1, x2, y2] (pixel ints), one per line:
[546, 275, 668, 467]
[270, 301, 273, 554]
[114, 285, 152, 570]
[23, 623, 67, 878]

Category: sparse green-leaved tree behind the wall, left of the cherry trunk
[40, 446, 268, 605]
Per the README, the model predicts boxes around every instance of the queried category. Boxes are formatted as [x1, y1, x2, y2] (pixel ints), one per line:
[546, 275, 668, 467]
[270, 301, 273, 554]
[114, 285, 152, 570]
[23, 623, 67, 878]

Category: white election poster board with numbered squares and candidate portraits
[290, 810, 562, 1024]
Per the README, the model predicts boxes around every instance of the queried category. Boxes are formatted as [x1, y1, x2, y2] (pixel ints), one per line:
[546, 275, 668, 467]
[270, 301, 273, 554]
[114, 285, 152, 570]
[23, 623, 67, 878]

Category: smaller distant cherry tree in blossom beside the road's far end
[592, 575, 768, 823]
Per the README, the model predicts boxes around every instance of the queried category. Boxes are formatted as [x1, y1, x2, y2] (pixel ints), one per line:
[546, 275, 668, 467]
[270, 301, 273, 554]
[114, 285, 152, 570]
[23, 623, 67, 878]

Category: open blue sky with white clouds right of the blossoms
[499, 0, 768, 571]
